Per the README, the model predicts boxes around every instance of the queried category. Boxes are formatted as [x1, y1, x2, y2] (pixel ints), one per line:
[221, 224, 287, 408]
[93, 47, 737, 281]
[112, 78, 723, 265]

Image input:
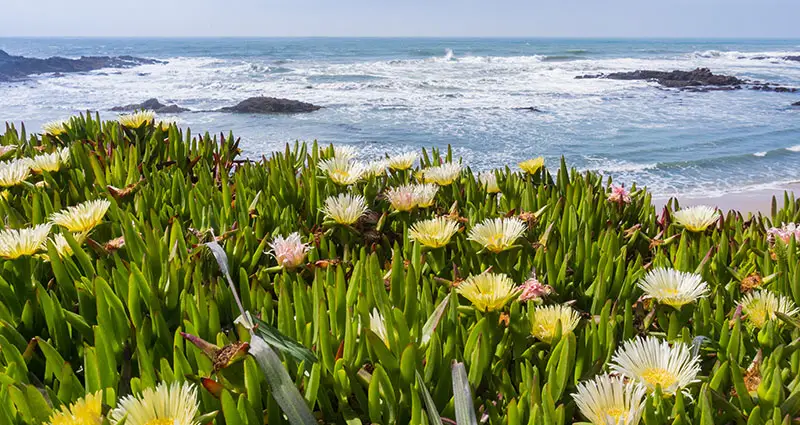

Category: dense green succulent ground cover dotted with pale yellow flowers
[0, 114, 800, 425]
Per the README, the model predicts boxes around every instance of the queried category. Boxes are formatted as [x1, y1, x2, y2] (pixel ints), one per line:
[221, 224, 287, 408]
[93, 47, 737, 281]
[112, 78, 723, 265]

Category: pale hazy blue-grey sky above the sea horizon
[0, 0, 800, 38]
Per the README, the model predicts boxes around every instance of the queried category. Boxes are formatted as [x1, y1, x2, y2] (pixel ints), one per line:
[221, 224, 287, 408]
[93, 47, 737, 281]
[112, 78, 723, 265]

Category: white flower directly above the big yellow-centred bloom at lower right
[639, 267, 708, 309]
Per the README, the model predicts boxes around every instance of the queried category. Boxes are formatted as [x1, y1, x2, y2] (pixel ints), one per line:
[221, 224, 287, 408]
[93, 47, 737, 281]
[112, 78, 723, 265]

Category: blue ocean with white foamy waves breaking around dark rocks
[0, 38, 800, 196]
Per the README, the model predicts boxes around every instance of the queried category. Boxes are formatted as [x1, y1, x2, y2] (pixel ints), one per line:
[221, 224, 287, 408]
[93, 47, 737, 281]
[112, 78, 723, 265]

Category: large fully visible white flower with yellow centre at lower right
[611, 336, 700, 395]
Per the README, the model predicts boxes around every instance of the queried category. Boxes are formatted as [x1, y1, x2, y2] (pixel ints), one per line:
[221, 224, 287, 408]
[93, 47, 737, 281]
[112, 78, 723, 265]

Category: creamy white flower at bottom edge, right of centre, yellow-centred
[572, 374, 647, 425]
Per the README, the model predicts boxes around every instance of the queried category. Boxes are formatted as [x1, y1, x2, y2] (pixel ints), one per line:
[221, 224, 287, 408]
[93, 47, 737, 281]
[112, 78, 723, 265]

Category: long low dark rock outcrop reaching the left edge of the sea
[0, 50, 165, 81]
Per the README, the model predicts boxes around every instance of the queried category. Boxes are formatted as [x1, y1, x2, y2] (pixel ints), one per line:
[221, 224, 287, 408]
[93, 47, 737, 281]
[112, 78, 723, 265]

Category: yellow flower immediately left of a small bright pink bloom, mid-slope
[456, 272, 519, 312]
